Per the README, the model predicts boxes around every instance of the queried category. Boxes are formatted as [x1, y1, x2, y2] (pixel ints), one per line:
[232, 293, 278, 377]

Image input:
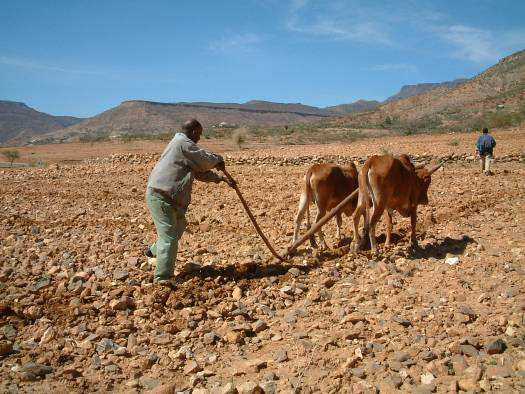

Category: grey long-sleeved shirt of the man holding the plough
[148, 133, 223, 210]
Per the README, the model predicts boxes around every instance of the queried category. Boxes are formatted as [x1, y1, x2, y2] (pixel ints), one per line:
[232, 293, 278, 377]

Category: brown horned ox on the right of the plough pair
[353, 155, 443, 252]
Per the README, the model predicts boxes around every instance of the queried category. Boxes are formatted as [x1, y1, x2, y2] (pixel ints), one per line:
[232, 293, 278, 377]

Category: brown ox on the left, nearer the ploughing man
[292, 163, 358, 249]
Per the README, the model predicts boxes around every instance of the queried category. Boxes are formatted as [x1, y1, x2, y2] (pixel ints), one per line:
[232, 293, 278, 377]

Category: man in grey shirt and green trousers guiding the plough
[144, 119, 232, 287]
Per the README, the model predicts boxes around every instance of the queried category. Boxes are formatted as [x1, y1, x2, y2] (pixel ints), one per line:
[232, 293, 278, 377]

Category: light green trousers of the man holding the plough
[146, 190, 186, 281]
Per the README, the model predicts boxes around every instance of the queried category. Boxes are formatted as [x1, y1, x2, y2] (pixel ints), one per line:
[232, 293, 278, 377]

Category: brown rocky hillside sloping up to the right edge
[332, 50, 525, 132]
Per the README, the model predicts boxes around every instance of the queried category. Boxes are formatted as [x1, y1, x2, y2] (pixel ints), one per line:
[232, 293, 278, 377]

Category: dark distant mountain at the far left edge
[0, 100, 83, 144]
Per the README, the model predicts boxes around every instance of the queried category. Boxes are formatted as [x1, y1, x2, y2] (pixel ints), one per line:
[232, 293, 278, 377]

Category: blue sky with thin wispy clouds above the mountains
[0, 0, 525, 116]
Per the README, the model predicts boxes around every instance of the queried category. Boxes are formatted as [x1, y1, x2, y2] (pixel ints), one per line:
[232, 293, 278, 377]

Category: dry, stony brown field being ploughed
[0, 130, 525, 393]
